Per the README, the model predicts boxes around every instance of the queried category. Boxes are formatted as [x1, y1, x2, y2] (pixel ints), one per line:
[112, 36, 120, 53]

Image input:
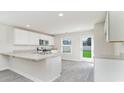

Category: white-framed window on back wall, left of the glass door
[61, 37, 72, 54]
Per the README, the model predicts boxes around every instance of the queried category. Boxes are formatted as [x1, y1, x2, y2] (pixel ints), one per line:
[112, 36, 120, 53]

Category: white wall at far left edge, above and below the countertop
[0, 24, 13, 70]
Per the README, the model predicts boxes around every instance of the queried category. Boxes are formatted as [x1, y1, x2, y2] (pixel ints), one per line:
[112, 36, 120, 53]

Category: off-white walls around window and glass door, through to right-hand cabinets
[55, 23, 114, 61]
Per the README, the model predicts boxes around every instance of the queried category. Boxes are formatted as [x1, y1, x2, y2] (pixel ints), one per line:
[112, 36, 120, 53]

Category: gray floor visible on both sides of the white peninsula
[0, 61, 93, 82]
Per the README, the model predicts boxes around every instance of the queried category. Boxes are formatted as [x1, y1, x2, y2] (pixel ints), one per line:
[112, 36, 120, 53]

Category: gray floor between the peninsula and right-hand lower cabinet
[54, 61, 94, 82]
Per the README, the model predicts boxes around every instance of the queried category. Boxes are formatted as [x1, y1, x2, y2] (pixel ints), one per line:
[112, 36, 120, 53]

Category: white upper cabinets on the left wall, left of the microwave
[14, 29, 39, 45]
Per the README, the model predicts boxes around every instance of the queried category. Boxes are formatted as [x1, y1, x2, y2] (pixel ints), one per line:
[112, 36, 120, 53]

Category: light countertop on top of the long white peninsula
[0, 52, 60, 61]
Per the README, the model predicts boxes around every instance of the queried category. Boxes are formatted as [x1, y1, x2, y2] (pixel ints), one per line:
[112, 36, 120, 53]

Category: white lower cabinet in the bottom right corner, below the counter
[94, 58, 124, 82]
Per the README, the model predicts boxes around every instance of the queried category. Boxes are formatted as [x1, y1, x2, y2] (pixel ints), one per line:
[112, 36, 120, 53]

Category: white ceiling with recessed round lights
[0, 11, 106, 34]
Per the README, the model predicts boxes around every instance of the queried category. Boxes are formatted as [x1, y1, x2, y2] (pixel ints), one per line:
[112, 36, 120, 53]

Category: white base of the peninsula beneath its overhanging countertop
[9, 55, 61, 82]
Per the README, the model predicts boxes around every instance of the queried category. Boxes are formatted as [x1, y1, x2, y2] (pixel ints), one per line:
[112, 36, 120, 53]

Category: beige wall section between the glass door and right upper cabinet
[94, 23, 114, 56]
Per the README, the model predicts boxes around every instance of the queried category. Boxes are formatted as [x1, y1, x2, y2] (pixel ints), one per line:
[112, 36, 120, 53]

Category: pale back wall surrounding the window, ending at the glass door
[54, 30, 93, 61]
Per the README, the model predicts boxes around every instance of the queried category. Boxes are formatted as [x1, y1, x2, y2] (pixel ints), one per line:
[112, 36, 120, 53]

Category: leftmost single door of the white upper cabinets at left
[14, 29, 28, 45]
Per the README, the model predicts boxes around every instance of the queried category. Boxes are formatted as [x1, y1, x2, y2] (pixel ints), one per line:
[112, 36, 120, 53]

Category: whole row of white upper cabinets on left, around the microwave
[14, 29, 54, 45]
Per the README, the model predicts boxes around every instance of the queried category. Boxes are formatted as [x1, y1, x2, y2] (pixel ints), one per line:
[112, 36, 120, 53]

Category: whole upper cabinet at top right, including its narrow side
[105, 11, 124, 42]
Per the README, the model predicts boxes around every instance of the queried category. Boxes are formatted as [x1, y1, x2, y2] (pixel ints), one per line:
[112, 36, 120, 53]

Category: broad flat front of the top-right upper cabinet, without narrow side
[109, 11, 124, 41]
